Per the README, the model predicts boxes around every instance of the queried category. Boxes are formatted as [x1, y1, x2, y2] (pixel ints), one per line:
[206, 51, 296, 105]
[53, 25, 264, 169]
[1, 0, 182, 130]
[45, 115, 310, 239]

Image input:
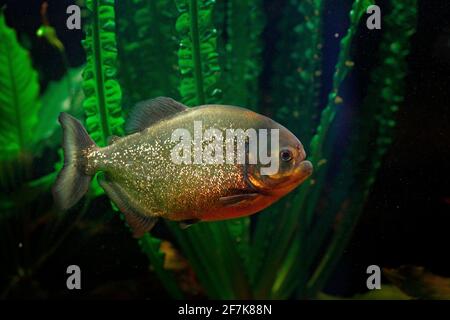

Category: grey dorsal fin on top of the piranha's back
[125, 97, 187, 134]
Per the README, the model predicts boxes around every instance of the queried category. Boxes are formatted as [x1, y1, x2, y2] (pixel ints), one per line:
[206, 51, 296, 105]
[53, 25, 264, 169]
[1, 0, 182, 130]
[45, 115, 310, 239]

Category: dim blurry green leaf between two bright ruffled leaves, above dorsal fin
[116, 0, 179, 107]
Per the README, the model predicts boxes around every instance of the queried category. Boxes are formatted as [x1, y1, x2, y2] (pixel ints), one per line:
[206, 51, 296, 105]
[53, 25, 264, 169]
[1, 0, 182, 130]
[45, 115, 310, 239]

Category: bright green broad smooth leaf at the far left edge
[0, 12, 41, 160]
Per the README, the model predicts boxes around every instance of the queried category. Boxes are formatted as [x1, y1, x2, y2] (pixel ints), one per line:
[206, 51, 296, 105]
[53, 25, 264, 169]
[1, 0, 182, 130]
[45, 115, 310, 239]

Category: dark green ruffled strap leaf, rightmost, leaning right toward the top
[309, 0, 417, 293]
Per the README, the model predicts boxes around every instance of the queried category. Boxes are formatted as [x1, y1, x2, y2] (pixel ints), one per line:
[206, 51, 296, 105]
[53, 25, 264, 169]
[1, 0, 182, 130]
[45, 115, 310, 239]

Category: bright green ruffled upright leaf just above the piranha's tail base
[83, 0, 124, 146]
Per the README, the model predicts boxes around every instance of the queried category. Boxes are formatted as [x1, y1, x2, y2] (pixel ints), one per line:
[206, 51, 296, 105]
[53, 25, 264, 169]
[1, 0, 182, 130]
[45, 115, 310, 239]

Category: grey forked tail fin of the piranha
[53, 112, 95, 210]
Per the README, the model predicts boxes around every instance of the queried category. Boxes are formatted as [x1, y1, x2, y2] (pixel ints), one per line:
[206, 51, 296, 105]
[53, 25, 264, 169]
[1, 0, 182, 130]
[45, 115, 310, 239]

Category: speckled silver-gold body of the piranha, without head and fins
[87, 105, 283, 220]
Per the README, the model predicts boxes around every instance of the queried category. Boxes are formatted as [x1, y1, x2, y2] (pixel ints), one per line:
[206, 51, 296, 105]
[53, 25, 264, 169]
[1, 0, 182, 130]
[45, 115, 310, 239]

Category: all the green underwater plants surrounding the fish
[0, 0, 426, 299]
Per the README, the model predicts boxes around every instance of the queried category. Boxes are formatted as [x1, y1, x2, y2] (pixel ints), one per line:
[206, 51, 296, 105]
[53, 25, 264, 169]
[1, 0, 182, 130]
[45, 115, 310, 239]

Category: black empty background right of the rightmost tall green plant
[331, 0, 450, 291]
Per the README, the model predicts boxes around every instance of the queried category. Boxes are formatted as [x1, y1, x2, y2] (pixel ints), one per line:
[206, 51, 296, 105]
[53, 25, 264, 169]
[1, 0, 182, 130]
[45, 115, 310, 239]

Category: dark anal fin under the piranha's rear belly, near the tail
[98, 175, 158, 238]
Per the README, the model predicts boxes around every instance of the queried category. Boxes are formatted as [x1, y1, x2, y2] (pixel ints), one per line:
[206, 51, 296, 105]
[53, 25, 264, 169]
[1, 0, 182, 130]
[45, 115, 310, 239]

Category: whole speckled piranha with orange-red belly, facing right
[53, 97, 313, 237]
